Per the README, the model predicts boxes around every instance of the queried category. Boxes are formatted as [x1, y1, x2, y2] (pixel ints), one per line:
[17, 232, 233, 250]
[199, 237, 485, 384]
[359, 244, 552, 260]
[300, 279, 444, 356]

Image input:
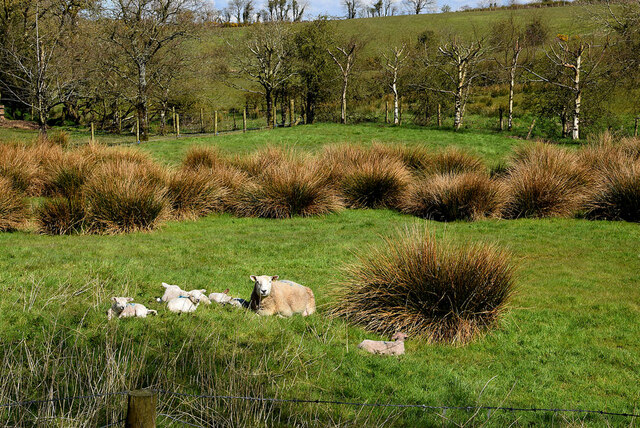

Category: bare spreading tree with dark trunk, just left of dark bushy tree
[231, 22, 295, 127]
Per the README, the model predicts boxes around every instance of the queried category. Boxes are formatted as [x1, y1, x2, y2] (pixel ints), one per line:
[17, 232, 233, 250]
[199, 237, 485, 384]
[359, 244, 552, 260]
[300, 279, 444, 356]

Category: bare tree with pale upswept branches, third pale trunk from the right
[425, 37, 488, 131]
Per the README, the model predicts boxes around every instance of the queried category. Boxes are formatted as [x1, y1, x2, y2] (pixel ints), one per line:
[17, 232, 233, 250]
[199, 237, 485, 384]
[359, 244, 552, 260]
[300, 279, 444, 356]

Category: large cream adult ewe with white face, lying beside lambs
[249, 275, 316, 317]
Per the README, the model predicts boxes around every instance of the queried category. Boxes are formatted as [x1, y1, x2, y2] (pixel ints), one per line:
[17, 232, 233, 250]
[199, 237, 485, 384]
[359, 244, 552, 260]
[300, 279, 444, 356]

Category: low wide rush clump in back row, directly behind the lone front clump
[401, 173, 503, 221]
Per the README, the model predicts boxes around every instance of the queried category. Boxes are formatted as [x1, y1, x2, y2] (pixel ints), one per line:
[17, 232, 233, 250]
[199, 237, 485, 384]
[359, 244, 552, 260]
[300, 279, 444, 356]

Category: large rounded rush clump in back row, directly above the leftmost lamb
[84, 160, 168, 233]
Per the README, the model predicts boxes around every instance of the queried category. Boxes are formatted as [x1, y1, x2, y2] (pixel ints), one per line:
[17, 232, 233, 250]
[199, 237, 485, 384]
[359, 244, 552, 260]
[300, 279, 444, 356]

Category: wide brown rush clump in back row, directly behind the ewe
[232, 155, 342, 218]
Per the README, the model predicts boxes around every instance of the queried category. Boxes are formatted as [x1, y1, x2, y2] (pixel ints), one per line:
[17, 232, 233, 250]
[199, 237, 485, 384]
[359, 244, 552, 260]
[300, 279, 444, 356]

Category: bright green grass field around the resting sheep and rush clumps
[0, 125, 640, 426]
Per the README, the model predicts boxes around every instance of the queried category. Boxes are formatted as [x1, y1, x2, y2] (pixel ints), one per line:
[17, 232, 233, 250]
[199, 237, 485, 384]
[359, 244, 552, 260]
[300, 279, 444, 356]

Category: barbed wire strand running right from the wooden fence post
[154, 389, 640, 418]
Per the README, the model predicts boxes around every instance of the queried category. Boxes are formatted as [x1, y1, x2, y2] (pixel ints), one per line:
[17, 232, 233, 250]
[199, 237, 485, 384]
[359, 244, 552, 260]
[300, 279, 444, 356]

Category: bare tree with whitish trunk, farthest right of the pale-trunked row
[527, 34, 608, 140]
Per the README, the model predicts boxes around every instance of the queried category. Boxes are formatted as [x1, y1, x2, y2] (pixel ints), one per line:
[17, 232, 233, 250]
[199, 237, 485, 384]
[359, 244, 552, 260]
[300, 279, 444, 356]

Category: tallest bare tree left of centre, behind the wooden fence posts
[106, 0, 197, 140]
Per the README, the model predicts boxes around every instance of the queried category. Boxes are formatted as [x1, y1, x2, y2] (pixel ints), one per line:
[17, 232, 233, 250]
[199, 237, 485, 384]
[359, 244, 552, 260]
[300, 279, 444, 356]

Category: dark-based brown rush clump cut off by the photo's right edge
[587, 161, 640, 222]
